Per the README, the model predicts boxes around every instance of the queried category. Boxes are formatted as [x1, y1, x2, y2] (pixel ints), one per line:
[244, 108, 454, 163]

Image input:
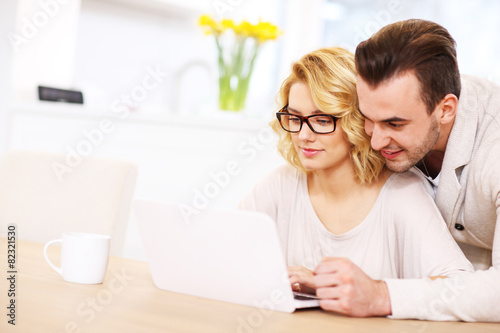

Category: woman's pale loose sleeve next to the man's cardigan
[390, 173, 473, 279]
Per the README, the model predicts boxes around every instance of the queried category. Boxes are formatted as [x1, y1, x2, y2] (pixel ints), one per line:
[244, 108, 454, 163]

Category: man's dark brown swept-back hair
[355, 19, 460, 113]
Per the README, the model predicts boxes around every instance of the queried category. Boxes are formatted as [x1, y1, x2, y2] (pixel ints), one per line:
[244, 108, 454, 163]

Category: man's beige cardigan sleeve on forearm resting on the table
[385, 176, 500, 322]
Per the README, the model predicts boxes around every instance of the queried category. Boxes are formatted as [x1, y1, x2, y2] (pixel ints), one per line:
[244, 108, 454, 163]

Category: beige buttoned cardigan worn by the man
[386, 76, 500, 322]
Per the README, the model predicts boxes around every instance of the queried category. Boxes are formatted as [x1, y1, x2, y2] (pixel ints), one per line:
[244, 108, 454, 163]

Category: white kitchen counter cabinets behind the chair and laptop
[8, 104, 284, 259]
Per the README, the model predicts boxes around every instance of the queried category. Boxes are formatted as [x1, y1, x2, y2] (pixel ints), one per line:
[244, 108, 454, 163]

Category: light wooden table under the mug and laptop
[0, 237, 500, 333]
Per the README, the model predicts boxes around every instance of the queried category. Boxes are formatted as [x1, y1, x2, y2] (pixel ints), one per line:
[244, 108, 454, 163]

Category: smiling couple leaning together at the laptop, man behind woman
[240, 20, 500, 321]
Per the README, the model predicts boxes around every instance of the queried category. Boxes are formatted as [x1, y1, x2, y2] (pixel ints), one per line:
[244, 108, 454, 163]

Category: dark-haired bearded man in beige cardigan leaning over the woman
[315, 20, 500, 322]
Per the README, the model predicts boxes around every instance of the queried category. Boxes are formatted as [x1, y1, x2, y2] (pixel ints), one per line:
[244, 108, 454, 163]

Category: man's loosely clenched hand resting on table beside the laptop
[314, 258, 392, 317]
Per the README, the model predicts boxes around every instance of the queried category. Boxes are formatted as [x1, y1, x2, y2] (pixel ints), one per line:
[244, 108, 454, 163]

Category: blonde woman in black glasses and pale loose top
[240, 48, 472, 292]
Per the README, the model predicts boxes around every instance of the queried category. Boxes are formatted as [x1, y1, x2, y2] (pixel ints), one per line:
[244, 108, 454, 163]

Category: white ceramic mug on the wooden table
[43, 232, 111, 284]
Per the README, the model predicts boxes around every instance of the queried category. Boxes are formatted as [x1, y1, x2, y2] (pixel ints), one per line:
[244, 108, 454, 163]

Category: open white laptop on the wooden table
[133, 200, 319, 313]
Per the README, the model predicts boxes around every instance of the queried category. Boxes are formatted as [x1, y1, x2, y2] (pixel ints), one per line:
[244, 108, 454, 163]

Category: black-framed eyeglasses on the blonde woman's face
[276, 105, 338, 134]
